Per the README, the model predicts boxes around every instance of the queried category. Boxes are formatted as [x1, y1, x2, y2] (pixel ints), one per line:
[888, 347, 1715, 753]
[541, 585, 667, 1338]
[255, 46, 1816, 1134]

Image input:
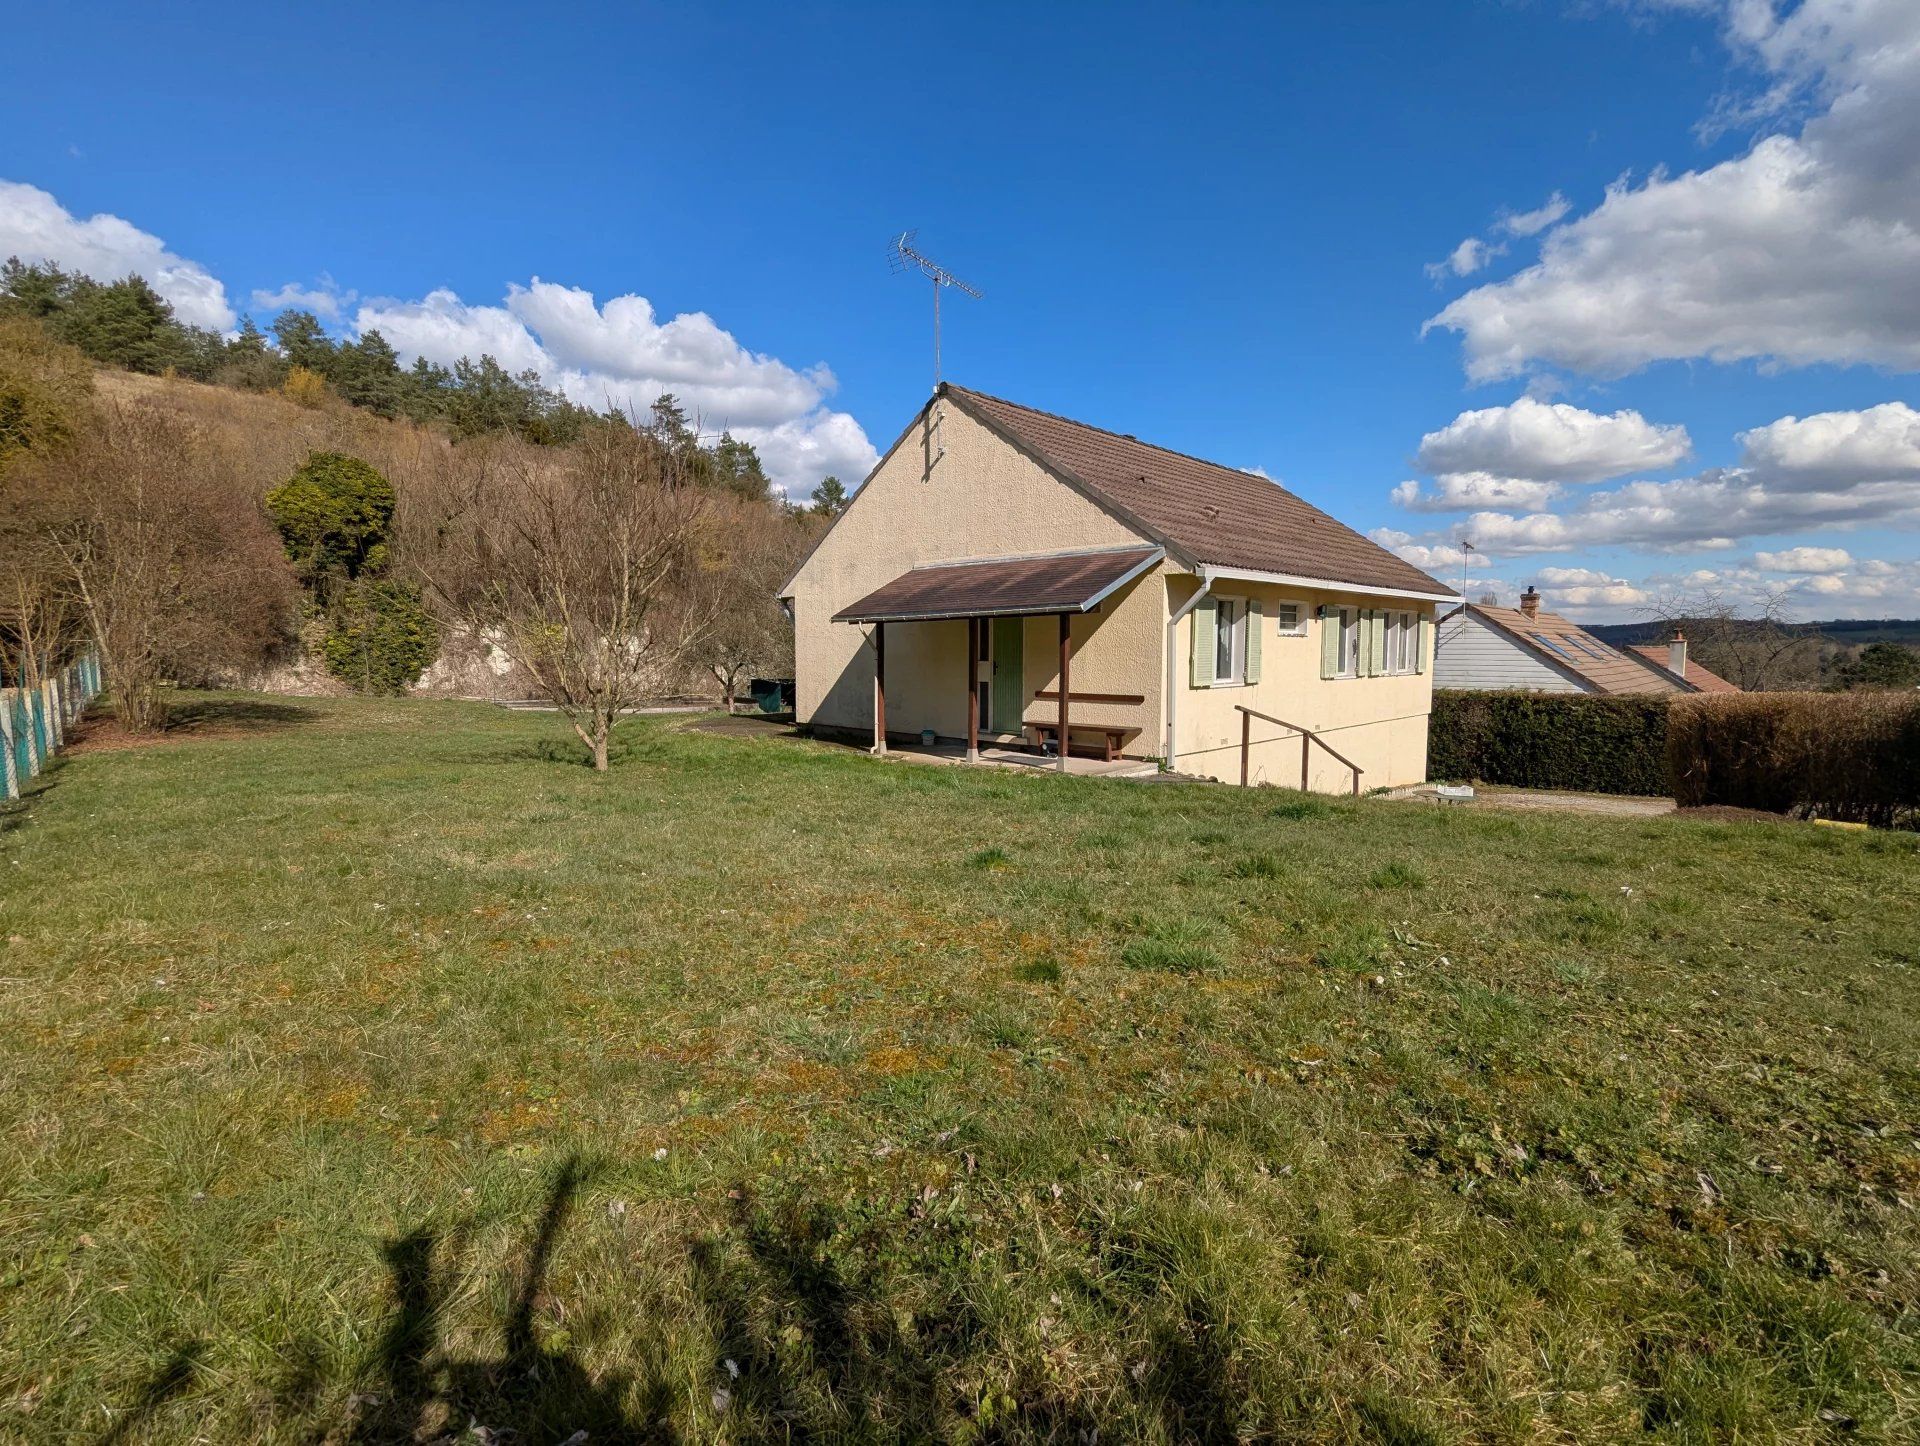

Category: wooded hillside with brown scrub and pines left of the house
[0, 289, 845, 737]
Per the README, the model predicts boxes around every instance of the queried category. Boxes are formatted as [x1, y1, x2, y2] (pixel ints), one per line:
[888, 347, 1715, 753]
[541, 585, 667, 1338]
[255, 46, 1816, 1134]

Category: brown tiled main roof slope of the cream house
[943, 382, 1453, 595]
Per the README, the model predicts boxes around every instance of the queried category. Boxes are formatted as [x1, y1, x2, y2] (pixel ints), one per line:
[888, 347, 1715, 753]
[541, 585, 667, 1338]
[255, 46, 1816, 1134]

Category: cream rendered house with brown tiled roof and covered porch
[781, 384, 1455, 791]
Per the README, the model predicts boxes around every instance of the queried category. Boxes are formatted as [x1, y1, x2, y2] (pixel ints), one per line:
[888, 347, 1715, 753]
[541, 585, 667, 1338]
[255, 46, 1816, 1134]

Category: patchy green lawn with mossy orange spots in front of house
[0, 697, 1920, 1444]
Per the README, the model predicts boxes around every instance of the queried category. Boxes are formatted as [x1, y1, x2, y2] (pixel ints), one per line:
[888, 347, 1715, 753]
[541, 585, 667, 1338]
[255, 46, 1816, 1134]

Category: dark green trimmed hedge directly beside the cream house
[1427, 689, 1668, 795]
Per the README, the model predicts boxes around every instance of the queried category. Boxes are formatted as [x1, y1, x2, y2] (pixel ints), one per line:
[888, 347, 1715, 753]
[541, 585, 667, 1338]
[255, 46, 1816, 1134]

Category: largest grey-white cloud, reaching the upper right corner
[1427, 0, 1920, 380]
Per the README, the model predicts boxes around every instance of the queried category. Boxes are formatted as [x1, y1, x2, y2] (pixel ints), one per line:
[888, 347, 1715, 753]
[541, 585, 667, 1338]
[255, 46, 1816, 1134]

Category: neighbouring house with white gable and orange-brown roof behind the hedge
[1434, 588, 1740, 693]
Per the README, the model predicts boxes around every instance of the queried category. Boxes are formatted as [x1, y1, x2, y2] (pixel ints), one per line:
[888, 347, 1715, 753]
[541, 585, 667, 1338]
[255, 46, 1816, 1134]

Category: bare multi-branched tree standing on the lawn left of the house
[417, 424, 726, 772]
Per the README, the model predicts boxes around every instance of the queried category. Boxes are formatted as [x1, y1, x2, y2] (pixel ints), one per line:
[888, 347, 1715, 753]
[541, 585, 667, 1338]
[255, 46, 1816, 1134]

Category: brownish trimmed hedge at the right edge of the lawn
[1668, 693, 1920, 828]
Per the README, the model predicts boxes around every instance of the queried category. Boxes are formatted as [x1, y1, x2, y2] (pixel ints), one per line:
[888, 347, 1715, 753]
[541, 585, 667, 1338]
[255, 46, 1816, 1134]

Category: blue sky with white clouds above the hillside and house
[0, 0, 1920, 620]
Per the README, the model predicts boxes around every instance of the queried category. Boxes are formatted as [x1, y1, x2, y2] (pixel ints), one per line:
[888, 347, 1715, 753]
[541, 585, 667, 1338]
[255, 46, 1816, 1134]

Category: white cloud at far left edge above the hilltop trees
[0, 181, 236, 332]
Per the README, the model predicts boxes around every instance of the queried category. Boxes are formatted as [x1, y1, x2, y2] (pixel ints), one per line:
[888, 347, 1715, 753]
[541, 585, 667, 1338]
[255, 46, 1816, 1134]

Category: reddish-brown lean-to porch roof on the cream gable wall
[833, 547, 1165, 622]
